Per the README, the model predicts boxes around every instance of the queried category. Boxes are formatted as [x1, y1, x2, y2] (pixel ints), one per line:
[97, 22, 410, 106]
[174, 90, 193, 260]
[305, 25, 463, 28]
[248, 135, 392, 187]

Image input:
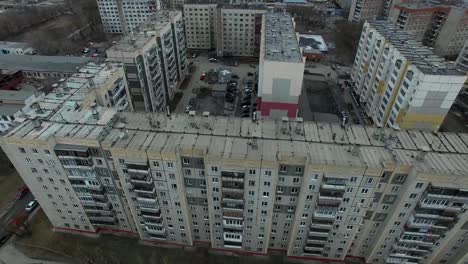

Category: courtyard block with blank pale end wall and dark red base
[257, 13, 305, 118]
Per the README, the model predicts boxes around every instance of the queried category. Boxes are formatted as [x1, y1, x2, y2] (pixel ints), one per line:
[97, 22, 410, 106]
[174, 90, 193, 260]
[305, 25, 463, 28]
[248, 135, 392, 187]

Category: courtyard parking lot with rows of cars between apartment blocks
[175, 54, 257, 117]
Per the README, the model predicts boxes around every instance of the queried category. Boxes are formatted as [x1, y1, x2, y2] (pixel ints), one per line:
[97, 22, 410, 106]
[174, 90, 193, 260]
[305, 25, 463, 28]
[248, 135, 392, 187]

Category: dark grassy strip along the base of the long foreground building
[18, 210, 300, 264]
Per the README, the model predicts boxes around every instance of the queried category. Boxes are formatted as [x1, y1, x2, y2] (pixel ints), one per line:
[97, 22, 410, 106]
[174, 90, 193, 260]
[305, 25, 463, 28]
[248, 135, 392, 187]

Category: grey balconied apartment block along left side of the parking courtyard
[107, 11, 187, 112]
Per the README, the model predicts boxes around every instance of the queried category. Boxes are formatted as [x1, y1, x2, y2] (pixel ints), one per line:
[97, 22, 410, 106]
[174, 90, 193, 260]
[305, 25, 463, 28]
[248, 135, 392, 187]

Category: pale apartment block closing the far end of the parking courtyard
[184, 4, 266, 57]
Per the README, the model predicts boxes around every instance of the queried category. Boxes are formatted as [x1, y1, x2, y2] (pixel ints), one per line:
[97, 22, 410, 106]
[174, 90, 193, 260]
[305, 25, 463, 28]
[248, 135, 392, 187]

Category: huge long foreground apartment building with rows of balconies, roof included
[4, 103, 468, 263]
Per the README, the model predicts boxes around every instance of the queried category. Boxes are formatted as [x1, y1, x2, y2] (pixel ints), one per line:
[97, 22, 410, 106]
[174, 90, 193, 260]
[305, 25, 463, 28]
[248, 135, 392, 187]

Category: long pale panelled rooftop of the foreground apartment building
[4, 108, 468, 176]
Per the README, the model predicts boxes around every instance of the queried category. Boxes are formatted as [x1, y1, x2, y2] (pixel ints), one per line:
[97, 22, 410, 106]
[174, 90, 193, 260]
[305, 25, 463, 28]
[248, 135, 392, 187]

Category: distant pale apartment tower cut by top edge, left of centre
[97, 0, 161, 34]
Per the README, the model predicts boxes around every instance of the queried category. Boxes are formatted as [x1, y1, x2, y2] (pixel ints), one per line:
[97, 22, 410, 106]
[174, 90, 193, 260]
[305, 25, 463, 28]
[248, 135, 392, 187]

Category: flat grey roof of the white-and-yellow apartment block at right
[368, 20, 465, 75]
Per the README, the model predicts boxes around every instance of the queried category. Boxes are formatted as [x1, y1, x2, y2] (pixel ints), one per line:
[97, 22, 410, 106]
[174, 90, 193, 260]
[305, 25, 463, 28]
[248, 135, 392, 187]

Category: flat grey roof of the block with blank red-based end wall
[262, 12, 302, 62]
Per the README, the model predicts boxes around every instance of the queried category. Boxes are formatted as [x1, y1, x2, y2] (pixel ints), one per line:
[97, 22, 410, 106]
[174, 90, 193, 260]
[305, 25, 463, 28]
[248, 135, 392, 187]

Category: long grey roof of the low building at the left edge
[0, 55, 99, 73]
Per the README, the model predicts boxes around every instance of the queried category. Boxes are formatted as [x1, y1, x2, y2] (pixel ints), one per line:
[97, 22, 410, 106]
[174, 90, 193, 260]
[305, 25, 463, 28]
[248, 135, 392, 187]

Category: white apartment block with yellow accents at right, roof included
[351, 21, 466, 131]
